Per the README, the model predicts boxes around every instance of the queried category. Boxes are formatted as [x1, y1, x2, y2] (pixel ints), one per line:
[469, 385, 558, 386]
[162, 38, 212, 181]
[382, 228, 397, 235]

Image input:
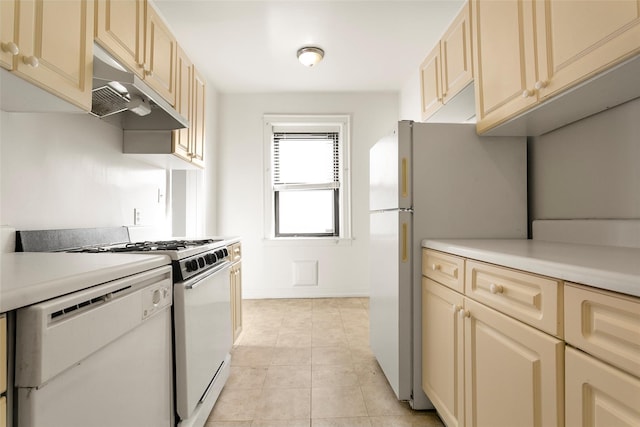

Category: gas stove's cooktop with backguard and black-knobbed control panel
[16, 227, 229, 282]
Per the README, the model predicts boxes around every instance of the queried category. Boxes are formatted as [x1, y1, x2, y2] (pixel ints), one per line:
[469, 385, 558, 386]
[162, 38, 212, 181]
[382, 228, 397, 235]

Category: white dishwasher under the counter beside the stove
[15, 266, 174, 427]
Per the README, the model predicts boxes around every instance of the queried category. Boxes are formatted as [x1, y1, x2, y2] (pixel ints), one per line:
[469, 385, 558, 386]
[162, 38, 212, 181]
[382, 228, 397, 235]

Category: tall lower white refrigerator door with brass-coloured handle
[369, 210, 412, 400]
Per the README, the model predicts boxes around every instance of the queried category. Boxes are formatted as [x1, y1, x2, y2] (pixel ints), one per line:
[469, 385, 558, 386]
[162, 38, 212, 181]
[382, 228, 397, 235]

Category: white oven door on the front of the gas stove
[174, 262, 233, 420]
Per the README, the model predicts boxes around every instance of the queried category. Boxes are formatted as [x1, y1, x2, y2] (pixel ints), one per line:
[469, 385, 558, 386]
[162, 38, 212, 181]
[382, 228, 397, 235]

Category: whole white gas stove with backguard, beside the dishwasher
[16, 231, 233, 427]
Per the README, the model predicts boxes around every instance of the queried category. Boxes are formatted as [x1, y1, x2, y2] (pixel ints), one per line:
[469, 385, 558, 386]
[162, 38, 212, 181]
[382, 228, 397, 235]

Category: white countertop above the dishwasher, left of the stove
[0, 252, 171, 313]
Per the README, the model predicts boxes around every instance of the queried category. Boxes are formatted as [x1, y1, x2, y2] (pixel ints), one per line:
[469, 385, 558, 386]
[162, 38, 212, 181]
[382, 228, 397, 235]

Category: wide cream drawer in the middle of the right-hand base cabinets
[465, 260, 563, 338]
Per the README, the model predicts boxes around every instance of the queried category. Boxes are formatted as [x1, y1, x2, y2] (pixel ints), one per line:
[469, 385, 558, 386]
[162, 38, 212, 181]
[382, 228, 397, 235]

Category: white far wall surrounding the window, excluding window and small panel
[218, 93, 398, 298]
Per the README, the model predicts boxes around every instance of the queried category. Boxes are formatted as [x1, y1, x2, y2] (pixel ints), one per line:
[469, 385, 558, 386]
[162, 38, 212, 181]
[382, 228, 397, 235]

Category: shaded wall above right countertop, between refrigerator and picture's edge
[529, 99, 640, 219]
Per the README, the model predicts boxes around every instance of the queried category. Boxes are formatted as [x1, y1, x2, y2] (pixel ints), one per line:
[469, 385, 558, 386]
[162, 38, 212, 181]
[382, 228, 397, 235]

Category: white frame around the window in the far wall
[263, 114, 351, 243]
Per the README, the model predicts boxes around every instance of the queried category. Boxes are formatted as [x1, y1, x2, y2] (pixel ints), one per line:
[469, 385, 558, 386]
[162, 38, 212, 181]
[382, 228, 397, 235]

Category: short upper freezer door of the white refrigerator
[369, 121, 412, 211]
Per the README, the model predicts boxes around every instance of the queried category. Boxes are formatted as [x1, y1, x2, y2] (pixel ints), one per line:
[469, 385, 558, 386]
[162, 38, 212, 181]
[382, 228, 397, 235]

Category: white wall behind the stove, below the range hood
[0, 111, 168, 237]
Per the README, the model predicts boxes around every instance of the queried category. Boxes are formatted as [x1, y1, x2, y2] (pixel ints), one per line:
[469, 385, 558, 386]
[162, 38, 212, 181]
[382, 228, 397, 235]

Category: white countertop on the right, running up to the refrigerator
[422, 239, 640, 297]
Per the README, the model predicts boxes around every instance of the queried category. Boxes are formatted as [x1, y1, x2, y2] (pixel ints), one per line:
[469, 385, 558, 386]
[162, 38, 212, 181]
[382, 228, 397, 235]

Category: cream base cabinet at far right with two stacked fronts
[565, 284, 640, 426]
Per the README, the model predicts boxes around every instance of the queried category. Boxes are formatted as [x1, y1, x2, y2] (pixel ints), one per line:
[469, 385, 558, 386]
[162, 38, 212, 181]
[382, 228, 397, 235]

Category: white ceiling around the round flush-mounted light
[153, 0, 464, 93]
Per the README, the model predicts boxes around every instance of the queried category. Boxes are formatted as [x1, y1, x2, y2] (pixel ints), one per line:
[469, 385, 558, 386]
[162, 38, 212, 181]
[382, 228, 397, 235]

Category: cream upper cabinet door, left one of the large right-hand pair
[471, 0, 537, 133]
